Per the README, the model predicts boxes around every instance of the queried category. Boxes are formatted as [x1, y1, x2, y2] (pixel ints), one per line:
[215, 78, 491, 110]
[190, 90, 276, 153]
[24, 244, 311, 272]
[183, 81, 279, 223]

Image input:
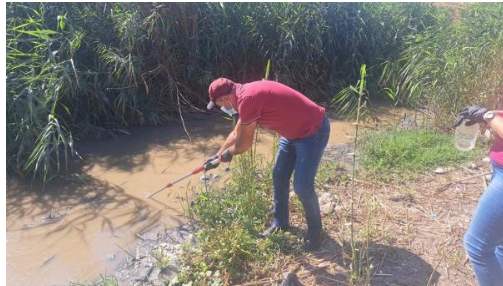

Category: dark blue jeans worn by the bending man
[273, 116, 330, 230]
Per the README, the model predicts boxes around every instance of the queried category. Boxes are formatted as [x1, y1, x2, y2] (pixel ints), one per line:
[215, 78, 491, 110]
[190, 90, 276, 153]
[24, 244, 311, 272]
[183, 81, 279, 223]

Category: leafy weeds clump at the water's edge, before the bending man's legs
[179, 147, 298, 285]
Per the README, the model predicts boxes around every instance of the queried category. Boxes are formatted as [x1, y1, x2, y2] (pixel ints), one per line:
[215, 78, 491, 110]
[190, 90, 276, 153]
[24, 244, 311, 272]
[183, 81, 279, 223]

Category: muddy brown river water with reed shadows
[6, 109, 414, 285]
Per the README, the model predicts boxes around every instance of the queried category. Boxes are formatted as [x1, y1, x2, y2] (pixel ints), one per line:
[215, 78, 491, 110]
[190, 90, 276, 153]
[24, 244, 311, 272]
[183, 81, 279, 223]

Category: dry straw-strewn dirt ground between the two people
[241, 161, 492, 286]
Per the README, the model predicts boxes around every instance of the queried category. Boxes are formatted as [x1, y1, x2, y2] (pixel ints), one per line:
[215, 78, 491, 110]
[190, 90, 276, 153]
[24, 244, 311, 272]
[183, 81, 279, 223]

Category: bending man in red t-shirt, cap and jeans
[208, 78, 330, 251]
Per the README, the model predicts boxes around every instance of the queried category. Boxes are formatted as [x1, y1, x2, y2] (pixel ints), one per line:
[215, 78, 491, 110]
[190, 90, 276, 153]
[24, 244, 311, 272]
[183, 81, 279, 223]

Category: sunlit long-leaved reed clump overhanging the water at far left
[6, 3, 82, 181]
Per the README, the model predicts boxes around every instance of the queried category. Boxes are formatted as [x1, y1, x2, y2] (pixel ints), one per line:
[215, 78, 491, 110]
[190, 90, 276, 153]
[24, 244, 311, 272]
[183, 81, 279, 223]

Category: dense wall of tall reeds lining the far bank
[6, 3, 503, 181]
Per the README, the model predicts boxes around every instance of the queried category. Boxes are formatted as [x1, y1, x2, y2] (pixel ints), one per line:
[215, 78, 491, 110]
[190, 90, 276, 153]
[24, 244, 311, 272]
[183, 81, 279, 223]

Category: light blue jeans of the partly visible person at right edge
[464, 163, 503, 286]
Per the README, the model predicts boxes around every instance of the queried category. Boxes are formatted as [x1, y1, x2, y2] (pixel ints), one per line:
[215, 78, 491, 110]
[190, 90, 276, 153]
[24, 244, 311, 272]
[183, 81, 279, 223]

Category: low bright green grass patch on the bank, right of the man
[360, 129, 487, 178]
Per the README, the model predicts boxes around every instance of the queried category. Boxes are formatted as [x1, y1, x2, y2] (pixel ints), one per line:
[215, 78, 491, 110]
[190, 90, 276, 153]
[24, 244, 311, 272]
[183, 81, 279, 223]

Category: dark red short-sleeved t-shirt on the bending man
[236, 81, 325, 139]
